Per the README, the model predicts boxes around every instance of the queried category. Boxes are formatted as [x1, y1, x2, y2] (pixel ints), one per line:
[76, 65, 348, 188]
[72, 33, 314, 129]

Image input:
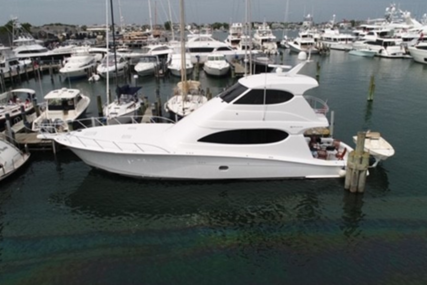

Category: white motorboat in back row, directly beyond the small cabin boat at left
[59, 48, 96, 79]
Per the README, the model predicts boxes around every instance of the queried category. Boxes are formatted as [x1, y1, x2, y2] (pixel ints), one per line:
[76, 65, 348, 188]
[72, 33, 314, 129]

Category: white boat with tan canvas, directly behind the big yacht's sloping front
[164, 80, 208, 121]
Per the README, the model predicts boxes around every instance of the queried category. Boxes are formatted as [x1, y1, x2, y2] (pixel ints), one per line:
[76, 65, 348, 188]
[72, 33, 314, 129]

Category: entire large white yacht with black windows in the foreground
[51, 63, 352, 180]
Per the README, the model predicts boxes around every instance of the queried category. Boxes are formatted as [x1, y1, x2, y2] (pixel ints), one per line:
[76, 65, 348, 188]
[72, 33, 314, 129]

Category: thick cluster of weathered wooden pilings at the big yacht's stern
[344, 132, 369, 193]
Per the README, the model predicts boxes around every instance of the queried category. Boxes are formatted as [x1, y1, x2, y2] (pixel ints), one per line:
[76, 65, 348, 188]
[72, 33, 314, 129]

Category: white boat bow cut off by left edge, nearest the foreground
[0, 140, 30, 181]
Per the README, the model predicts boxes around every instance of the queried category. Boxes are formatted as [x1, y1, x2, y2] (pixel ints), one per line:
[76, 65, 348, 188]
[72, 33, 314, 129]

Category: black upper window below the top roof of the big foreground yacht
[234, 89, 294, 105]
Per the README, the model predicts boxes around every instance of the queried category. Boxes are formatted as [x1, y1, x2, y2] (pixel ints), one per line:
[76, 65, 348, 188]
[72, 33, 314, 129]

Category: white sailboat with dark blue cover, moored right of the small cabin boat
[103, 85, 144, 125]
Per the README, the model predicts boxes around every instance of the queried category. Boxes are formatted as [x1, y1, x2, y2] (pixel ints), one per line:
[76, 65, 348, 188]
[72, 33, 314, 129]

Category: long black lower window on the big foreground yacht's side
[199, 129, 288, 144]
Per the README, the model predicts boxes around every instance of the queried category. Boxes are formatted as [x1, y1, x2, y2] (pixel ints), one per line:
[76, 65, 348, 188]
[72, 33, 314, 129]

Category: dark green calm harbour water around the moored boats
[0, 32, 427, 284]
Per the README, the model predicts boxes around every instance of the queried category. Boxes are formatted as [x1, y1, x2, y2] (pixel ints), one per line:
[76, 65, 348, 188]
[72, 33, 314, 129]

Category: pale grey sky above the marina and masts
[0, 0, 427, 26]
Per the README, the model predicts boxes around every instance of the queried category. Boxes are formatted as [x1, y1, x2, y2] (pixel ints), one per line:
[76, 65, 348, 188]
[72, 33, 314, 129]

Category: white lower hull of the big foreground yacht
[69, 146, 345, 180]
